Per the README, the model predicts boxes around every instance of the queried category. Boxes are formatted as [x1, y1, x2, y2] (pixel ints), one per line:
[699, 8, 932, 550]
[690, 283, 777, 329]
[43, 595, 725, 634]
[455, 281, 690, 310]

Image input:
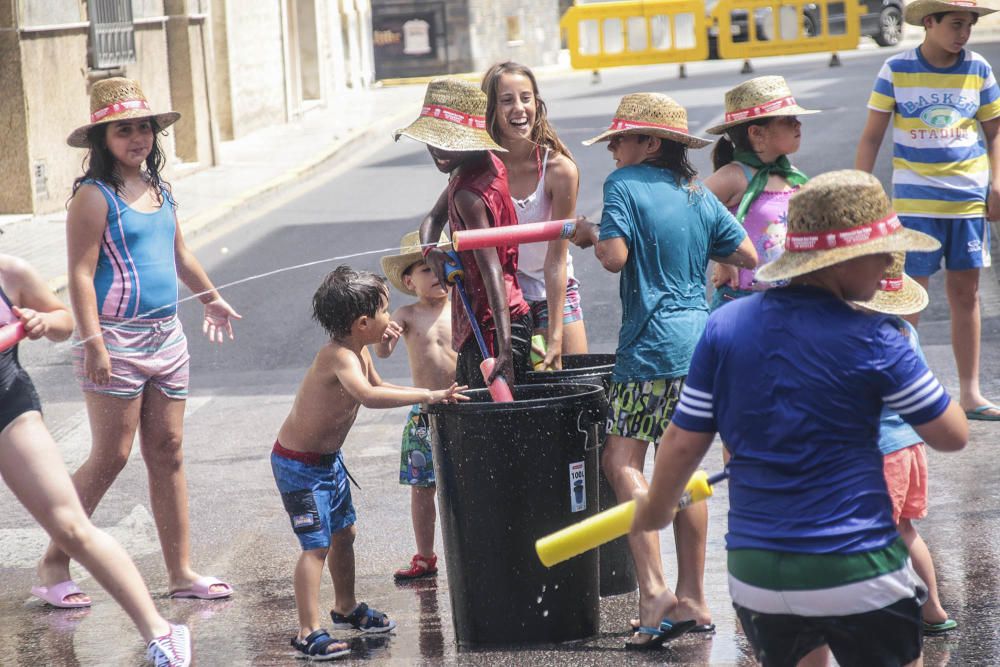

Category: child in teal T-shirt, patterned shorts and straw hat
[572, 93, 757, 648]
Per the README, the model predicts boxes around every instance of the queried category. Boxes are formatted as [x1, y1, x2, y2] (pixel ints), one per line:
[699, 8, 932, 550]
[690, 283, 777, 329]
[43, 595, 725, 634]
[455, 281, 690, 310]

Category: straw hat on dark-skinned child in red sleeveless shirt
[392, 77, 507, 153]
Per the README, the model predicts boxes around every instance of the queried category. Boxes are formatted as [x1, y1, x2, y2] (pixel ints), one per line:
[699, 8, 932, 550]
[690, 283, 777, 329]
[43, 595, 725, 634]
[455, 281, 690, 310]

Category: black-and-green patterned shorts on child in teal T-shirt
[607, 376, 687, 442]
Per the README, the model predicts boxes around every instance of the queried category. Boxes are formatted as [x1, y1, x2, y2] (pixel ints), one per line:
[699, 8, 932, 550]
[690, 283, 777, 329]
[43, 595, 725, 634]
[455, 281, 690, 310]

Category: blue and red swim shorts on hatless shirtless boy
[271, 441, 357, 551]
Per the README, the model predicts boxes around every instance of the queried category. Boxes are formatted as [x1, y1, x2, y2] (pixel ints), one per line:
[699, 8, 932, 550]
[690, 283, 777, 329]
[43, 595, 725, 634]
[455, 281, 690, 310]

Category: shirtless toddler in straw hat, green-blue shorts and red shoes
[375, 232, 456, 580]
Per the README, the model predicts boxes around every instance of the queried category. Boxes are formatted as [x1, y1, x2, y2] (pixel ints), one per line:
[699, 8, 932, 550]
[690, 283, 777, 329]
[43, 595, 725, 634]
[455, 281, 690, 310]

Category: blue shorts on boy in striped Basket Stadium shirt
[899, 215, 990, 276]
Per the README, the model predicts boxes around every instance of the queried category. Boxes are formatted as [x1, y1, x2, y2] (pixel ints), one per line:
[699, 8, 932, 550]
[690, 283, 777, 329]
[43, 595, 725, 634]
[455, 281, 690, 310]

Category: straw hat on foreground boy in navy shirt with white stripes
[757, 169, 941, 282]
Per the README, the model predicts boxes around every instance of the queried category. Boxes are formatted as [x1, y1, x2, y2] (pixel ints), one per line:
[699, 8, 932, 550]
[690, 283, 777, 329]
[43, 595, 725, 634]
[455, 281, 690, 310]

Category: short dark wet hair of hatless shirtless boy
[313, 266, 389, 340]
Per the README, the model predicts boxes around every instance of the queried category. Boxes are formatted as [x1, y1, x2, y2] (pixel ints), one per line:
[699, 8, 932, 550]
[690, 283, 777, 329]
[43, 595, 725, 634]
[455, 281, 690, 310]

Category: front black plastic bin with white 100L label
[428, 384, 607, 646]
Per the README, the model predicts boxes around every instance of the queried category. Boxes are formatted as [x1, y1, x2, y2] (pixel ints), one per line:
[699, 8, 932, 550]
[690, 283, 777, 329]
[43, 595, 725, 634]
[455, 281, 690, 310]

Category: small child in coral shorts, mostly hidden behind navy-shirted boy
[855, 253, 958, 635]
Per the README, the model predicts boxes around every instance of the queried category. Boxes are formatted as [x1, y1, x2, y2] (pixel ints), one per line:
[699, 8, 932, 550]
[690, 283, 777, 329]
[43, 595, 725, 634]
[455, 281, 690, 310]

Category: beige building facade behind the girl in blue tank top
[0, 0, 373, 214]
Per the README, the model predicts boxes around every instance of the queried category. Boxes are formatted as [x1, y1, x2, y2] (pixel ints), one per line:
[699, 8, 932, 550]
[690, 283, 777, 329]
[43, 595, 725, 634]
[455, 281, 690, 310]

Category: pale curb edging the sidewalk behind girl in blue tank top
[48, 101, 413, 294]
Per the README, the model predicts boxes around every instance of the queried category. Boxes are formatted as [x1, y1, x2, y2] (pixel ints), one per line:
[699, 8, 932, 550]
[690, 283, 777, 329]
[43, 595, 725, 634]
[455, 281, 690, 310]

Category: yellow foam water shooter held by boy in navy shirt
[535, 470, 729, 567]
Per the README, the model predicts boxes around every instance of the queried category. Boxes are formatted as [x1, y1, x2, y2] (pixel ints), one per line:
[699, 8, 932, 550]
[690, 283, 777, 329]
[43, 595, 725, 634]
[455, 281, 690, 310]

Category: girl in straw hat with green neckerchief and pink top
[705, 76, 819, 310]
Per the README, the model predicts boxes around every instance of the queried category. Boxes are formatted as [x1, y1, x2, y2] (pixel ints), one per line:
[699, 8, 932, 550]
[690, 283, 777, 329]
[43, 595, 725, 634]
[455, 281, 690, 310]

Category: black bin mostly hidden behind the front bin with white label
[528, 354, 638, 597]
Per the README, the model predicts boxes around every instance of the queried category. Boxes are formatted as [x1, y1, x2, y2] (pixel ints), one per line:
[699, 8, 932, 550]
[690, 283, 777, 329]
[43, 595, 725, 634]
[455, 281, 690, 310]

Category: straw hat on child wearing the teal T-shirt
[583, 93, 712, 148]
